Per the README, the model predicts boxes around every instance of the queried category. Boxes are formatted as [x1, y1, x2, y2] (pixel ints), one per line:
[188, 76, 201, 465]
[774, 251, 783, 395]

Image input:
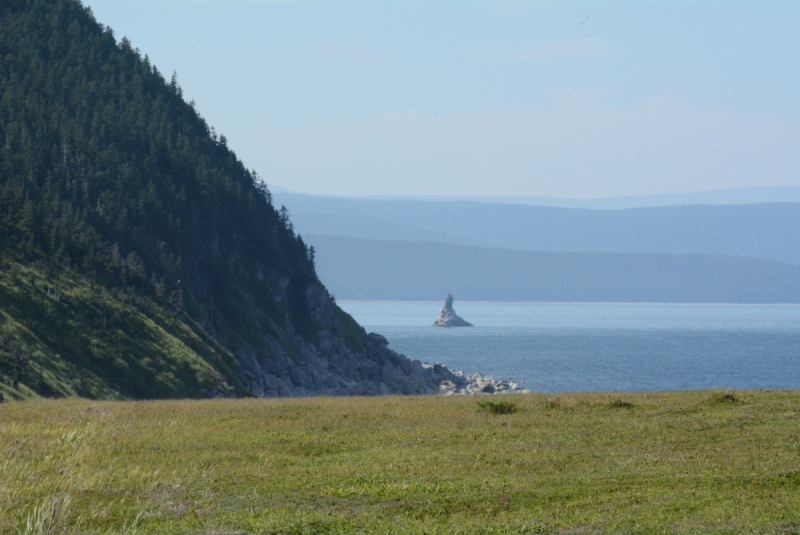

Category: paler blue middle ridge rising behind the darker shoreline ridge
[275, 193, 800, 265]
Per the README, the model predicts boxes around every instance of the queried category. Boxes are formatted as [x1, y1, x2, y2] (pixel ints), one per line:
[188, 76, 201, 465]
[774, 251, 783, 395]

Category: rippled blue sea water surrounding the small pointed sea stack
[339, 301, 800, 392]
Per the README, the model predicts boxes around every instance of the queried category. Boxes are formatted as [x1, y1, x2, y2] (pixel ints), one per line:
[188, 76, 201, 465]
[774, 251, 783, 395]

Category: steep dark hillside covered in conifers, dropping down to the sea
[0, 0, 450, 397]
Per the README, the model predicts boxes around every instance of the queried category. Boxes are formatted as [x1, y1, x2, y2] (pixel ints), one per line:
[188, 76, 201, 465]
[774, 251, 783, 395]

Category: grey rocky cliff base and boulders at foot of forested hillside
[228, 285, 522, 397]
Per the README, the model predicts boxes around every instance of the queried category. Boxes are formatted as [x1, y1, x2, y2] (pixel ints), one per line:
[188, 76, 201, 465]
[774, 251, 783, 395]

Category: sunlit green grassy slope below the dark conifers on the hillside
[0, 261, 245, 398]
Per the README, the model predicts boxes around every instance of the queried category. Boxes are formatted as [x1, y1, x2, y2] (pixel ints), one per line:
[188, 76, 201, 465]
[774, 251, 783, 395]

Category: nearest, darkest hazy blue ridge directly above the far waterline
[306, 236, 800, 303]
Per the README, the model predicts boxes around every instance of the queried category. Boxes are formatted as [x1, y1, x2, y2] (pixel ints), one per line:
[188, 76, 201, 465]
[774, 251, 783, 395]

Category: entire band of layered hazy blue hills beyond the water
[266, 188, 800, 303]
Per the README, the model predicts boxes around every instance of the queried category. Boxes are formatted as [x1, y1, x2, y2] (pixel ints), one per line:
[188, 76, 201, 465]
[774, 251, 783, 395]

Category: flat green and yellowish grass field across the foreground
[0, 391, 800, 534]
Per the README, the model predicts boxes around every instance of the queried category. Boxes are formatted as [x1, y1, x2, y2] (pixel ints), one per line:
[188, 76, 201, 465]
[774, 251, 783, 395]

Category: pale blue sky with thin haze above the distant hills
[84, 0, 800, 198]
